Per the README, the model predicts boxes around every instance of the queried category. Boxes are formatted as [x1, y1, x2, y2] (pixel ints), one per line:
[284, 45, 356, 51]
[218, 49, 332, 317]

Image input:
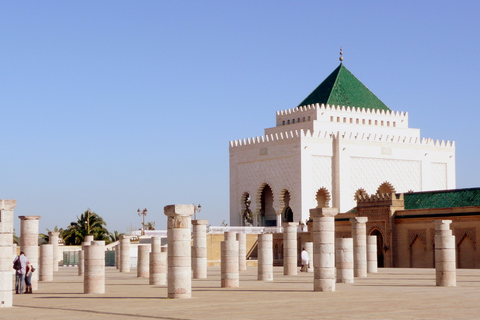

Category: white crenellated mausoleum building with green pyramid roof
[230, 64, 455, 226]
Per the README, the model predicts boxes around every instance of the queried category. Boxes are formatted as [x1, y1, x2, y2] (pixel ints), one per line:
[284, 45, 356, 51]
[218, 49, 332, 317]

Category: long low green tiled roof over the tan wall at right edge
[404, 188, 480, 210]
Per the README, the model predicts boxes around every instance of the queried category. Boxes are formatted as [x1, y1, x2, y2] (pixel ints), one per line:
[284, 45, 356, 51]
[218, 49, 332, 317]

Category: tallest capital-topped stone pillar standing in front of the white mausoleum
[310, 208, 338, 292]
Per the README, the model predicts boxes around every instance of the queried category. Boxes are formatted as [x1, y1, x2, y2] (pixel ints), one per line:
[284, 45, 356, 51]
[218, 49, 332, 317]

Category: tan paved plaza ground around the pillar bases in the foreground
[0, 267, 480, 320]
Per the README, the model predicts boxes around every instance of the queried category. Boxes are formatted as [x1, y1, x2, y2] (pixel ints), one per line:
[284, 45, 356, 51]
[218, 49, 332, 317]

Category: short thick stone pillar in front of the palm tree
[83, 241, 105, 294]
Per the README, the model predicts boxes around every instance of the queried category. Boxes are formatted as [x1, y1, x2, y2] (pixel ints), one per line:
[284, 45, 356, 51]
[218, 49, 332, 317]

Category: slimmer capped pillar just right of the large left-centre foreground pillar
[192, 220, 208, 279]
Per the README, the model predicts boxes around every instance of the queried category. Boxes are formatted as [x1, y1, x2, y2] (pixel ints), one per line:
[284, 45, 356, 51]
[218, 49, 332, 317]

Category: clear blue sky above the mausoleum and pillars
[0, 0, 480, 234]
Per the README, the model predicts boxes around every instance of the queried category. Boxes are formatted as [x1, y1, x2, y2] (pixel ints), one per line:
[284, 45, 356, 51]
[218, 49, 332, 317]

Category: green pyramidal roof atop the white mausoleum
[298, 64, 390, 110]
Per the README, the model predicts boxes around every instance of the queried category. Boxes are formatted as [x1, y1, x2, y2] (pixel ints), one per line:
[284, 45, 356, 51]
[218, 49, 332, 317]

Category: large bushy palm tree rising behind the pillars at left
[62, 209, 109, 246]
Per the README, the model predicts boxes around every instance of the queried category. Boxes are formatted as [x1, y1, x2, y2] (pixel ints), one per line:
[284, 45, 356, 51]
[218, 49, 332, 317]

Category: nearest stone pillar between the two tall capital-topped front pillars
[220, 232, 240, 288]
